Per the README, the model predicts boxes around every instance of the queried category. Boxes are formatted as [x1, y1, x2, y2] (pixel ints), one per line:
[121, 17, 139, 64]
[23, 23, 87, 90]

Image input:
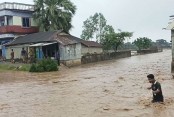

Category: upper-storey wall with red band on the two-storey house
[0, 10, 39, 34]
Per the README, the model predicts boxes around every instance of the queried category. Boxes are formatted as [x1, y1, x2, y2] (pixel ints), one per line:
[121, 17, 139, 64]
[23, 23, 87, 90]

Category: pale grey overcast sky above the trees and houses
[1, 0, 174, 41]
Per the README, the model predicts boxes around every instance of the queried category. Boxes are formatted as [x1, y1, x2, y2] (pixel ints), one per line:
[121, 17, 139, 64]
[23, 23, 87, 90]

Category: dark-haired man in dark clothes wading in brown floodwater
[147, 74, 164, 103]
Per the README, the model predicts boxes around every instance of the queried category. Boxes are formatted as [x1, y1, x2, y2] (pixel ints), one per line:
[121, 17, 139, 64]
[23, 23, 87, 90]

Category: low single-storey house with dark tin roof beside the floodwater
[5, 30, 102, 66]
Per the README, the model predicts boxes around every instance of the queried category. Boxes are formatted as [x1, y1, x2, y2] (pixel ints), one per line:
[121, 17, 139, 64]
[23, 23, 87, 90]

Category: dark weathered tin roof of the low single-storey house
[7, 30, 101, 47]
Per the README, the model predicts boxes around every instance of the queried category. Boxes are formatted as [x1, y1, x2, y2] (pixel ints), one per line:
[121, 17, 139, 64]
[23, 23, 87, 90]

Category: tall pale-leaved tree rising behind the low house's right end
[81, 13, 106, 42]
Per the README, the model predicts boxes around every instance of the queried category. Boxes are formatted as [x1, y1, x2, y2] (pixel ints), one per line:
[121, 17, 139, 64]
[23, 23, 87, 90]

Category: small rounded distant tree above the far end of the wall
[133, 37, 152, 50]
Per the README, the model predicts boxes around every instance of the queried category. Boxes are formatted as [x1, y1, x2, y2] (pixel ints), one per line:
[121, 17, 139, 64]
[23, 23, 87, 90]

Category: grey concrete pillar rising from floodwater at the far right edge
[171, 30, 174, 73]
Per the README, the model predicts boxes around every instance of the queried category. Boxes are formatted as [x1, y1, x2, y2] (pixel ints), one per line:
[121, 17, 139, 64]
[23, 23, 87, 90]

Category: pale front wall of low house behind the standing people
[5, 45, 28, 59]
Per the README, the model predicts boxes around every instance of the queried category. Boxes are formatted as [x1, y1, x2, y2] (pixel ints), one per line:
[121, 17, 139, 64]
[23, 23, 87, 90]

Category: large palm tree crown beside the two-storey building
[34, 0, 76, 32]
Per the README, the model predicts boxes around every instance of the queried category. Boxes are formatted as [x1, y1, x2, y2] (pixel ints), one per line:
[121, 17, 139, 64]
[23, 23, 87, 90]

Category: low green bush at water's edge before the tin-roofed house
[29, 59, 58, 72]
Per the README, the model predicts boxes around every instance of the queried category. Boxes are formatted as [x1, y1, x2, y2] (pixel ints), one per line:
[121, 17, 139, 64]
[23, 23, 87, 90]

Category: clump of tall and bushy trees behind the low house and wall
[81, 13, 133, 51]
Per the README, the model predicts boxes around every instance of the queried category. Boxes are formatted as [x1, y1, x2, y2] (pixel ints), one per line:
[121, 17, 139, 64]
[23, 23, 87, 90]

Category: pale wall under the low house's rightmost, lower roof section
[82, 45, 103, 55]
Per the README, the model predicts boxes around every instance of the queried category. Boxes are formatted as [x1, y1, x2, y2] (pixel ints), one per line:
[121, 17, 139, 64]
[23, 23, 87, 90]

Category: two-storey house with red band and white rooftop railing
[0, 2, 39, 56]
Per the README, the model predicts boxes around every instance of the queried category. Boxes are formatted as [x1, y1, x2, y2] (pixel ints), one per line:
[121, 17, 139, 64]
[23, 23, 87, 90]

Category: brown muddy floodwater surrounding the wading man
[0, 50, 174, 117]
